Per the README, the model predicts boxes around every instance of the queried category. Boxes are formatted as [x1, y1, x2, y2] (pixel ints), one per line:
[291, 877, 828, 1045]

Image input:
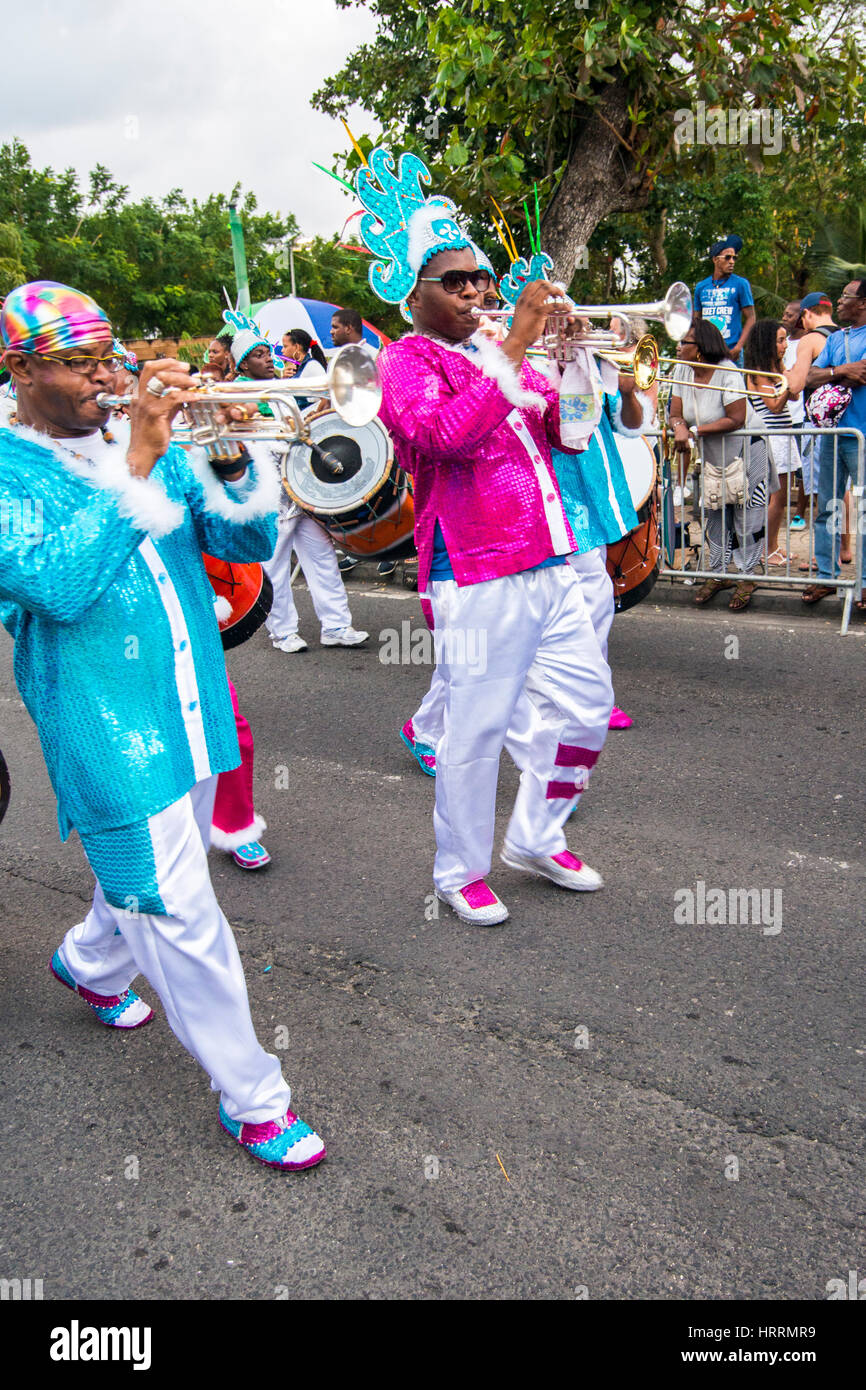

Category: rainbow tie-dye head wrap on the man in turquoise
[0, 279, 111, 353]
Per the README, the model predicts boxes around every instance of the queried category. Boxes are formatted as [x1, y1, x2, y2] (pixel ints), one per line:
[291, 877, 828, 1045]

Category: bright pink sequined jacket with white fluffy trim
[378, 334, 578, 594]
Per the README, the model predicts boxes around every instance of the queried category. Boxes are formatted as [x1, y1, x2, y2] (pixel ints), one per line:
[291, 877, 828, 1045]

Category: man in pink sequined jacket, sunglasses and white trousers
[378, 247, 613, 926]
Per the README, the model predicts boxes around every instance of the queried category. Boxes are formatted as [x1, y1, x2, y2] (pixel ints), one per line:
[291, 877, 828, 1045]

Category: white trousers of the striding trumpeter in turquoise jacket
[60, 777, 292, 1125]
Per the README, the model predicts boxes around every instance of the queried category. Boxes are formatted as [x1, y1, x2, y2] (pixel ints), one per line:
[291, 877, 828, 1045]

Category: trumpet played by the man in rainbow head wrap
[96, 343, 382, 474]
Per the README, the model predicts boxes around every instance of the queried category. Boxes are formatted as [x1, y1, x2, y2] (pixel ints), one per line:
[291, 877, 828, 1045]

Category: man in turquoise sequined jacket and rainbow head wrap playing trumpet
[0, 281, 325, 1169]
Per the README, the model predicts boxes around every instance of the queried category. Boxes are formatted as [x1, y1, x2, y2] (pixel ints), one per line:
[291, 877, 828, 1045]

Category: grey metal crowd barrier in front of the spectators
[649, 425, 866, 635]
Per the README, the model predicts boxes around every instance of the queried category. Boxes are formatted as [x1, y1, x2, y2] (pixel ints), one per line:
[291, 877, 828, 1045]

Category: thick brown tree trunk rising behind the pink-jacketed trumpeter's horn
[542, 82, 649, 285]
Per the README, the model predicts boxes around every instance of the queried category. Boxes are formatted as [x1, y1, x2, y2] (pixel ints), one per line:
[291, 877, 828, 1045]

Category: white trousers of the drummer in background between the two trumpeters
[264, 512, 352, 642]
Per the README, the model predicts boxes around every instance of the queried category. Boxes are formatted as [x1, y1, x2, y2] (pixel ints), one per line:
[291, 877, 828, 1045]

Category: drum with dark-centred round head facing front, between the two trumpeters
[282, 410, 416, 560]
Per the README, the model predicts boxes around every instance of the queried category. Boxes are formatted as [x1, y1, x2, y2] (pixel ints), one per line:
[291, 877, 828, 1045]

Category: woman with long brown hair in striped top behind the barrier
[745, 318, 802, 566]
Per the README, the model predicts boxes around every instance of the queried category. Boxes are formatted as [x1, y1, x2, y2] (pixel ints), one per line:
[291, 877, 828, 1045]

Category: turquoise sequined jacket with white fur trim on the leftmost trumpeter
[0, 428, 279, 840]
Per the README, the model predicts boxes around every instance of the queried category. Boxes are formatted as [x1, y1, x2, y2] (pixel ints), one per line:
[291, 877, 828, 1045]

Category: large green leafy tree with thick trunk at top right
[313, 0, 866, 281]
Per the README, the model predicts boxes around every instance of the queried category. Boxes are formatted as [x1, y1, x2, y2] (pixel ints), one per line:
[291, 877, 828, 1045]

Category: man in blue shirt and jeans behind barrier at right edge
[803, 279, 866, 612]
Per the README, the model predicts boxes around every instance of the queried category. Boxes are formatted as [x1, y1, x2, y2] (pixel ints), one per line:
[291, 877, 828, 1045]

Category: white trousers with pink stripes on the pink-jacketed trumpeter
[430, 564, 613, 891]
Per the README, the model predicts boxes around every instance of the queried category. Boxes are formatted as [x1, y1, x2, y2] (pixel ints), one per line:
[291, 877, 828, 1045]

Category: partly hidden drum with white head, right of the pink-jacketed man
[607, 435, 662, 613]
